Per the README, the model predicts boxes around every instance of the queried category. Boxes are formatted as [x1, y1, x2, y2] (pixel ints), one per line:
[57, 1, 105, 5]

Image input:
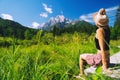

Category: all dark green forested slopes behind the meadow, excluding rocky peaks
[0, 18, 95, 40]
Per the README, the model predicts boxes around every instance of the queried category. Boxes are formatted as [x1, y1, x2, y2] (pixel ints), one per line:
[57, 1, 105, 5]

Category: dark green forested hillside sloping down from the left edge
[0, 18, 38, 39]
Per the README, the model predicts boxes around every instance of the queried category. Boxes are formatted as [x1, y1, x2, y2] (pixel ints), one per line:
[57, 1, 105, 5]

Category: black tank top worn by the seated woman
[95, 27, 110, 50]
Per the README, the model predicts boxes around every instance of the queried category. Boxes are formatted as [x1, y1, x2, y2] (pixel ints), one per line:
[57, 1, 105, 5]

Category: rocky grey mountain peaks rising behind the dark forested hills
[39, 15, 92, 31]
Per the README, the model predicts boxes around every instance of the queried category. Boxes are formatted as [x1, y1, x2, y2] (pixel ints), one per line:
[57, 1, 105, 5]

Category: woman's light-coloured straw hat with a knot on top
[93, 8, 109, 26]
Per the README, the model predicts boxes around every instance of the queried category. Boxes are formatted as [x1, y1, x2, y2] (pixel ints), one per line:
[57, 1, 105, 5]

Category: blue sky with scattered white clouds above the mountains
[0, 0, 120, 28]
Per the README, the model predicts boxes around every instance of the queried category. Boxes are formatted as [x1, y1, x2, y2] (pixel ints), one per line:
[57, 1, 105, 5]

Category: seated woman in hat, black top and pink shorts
[79, 8, 110, 75]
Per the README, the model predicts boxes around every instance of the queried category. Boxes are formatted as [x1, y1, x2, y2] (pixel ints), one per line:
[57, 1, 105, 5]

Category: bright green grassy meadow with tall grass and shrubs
[0, 33, 120, 80]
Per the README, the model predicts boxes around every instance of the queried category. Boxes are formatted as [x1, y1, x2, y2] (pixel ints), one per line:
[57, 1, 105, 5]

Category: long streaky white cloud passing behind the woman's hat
[79, 6, 118, 24]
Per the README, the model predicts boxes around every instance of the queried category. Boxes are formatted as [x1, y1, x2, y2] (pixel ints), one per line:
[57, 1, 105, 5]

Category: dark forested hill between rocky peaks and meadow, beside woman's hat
[51, 21, 96, 35]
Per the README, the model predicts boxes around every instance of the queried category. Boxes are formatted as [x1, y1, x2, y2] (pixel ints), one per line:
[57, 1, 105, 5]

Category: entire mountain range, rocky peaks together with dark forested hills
[0, 15, 94, 39]
